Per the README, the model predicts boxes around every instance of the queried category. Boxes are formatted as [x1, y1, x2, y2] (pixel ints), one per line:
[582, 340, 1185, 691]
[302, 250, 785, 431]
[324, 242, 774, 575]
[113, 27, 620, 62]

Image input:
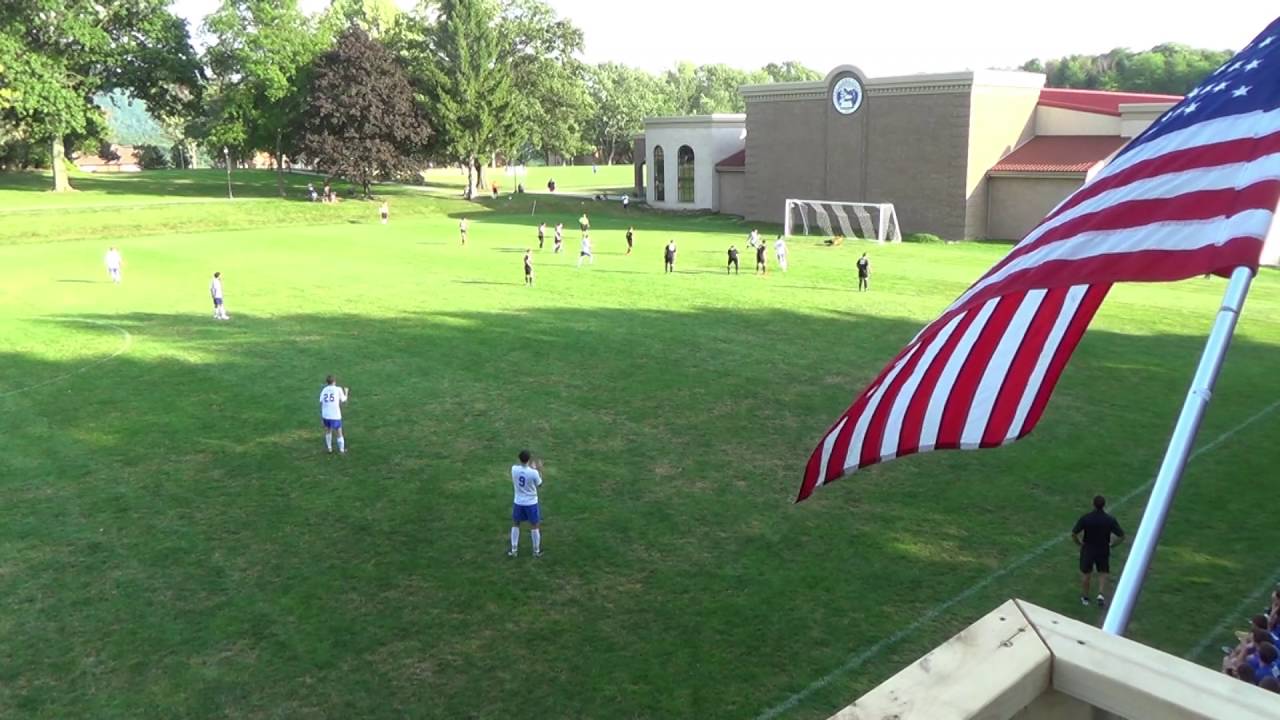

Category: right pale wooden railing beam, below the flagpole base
[1018, 601, 1280, 720]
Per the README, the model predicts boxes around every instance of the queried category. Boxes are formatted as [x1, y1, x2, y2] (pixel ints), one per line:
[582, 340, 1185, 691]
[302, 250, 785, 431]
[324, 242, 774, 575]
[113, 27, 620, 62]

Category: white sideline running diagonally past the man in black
[756, 400, 1280, 720]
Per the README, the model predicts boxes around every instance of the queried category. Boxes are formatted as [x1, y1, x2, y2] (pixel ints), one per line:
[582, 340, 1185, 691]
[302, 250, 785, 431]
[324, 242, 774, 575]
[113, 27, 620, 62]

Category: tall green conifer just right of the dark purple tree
[397, 0, 522, 197]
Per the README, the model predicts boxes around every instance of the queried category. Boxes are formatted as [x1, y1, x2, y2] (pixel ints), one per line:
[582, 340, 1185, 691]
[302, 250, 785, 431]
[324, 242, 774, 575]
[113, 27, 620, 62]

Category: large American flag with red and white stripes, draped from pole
[796, 19, 1280, 502]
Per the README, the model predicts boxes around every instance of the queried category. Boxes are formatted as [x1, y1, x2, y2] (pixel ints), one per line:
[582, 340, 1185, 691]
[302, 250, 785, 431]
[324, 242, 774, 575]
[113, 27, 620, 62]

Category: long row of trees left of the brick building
[0, 0, 820, 192]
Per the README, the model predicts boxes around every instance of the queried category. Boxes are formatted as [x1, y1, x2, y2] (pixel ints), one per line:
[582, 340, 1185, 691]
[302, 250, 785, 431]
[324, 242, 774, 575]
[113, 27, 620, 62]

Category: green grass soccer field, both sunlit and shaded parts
[0, 172, 1280, 719]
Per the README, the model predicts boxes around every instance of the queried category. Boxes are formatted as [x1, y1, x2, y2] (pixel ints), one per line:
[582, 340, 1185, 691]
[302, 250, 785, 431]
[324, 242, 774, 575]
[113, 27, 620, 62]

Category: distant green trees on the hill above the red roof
[1019, 42, 1235, 95]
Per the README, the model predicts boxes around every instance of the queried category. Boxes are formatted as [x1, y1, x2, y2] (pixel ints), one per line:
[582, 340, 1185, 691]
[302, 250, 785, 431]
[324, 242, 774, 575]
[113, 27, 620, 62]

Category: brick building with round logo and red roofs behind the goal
[635, 65, 1180, 238]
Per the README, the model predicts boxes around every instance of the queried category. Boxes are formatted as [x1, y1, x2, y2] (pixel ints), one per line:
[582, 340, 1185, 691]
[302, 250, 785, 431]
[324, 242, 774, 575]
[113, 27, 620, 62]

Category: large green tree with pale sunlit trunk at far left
[0, 0, 201, 190]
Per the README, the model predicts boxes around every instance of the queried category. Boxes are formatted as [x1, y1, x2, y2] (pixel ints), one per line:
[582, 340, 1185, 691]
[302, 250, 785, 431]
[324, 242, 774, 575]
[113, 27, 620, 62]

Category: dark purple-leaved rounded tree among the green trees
[298, 26, 430, 197]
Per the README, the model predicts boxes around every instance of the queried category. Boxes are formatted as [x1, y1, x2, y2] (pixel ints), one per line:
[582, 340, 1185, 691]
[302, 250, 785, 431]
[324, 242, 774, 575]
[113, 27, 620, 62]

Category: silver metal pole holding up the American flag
[1102, 266, 1253, 635]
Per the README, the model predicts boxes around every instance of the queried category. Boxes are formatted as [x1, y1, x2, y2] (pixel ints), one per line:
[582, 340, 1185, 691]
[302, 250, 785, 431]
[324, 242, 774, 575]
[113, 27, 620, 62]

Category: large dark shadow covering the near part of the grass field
[0, 307, 1280, 717]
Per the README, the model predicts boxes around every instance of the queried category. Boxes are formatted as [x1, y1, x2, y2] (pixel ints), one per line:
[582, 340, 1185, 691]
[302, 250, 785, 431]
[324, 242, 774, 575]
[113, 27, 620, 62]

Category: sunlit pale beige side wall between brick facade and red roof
[951, 70, 1044, 240]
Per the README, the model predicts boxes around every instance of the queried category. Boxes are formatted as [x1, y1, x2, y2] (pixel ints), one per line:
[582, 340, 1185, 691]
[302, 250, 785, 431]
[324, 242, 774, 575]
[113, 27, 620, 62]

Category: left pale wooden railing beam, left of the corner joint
[832, 601, 1054, 720]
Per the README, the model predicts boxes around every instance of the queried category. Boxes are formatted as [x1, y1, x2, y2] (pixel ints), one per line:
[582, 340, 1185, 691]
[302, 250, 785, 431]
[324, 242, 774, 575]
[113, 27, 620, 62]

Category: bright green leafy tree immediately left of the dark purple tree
[205, 0, 324, 197]
